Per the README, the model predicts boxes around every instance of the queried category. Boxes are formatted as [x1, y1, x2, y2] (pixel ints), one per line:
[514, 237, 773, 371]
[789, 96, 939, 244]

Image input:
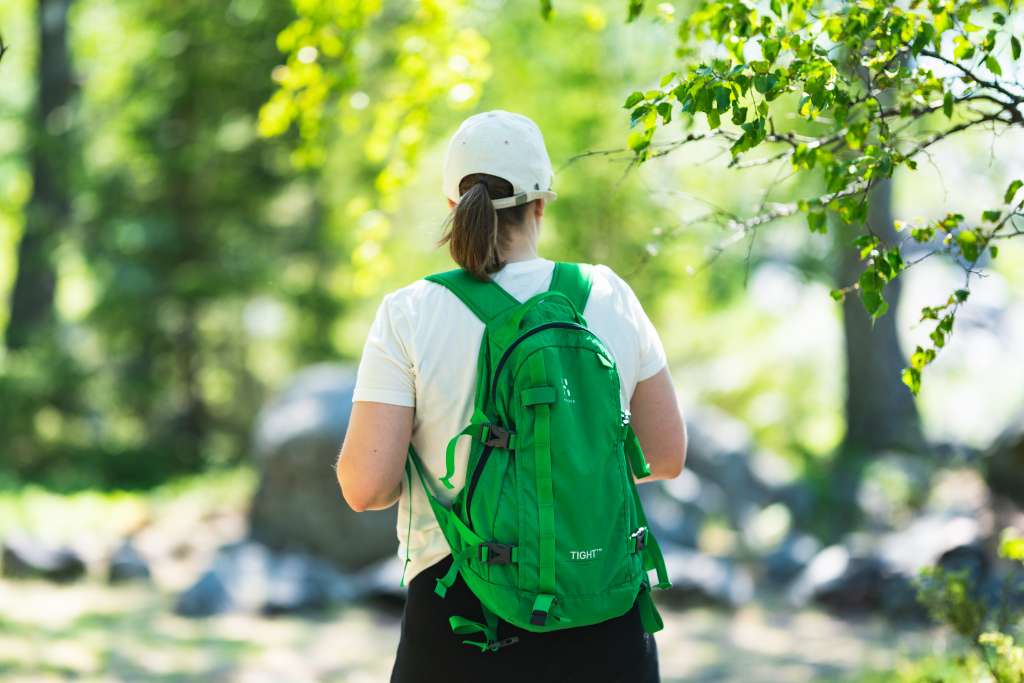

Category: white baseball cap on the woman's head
[442, 110, 558, 209]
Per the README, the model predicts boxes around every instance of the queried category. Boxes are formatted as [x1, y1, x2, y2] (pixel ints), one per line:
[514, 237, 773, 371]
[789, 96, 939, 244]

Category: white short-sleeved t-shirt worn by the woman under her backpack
[353, 257, 666, 583]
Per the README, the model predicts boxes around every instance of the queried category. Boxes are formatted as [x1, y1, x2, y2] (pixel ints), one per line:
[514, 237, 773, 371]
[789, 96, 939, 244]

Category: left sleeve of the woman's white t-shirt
[352, 293, 416, 408]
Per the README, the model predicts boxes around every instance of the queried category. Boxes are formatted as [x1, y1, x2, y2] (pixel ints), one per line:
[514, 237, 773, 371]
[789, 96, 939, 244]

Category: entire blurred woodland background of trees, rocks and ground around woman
[0, 0, 1024, 682]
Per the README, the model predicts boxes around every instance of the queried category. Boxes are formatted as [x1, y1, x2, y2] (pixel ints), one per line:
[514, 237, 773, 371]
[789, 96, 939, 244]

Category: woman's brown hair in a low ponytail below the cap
[437, 173, 532, 281]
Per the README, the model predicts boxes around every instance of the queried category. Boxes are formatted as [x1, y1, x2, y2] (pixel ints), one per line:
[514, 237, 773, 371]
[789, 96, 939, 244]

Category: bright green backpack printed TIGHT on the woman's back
[406, 263, 670, 651]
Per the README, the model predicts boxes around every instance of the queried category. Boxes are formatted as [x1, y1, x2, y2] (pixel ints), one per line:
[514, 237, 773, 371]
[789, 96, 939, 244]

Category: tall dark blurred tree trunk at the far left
[6, 0, 73, 349]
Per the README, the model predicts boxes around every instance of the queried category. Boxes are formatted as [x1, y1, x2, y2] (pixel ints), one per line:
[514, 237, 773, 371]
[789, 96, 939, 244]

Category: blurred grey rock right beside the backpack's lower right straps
[663, 546, 754, 607]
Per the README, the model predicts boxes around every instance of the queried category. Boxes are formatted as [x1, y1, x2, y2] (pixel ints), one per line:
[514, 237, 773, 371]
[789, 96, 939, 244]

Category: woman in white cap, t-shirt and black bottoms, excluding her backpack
[338, 110, 686, 683]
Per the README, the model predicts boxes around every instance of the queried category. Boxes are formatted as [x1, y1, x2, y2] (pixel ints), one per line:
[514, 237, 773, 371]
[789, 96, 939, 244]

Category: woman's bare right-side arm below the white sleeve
[630, 366, 686, 482]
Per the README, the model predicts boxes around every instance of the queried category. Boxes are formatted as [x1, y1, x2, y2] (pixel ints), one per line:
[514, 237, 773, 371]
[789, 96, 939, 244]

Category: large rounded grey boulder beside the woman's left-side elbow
[250, 365, 397, 571]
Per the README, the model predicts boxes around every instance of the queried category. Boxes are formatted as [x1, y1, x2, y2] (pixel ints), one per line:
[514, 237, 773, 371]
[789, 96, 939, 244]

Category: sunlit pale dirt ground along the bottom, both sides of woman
[0, 580, 947, 683]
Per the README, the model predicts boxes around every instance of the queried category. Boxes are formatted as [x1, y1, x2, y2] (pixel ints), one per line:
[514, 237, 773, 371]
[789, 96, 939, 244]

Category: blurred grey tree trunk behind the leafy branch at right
[838, 179, 924, 453]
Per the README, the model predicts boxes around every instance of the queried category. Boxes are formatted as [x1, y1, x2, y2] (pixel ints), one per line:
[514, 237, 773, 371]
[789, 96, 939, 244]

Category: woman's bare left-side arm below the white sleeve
[337, 400, 415, 512]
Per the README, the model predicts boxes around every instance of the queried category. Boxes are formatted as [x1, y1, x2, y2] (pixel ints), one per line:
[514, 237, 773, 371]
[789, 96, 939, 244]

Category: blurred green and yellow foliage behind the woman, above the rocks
[0, 0, 1020, 489]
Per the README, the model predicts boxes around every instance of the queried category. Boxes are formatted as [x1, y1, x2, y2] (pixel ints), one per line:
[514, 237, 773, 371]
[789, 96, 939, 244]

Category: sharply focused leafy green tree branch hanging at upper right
[624, 0, 1024, 394]
